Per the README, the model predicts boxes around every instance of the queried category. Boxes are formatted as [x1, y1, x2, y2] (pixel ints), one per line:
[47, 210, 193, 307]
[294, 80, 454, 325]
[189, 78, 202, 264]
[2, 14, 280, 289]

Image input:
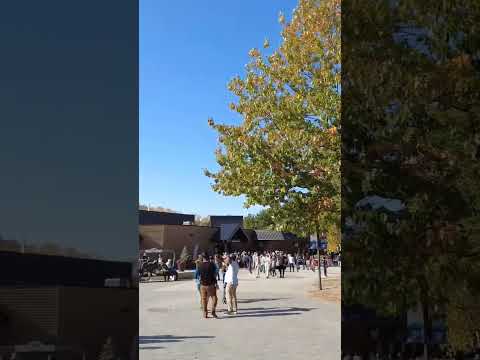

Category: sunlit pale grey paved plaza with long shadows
[140, 268, 341, 360]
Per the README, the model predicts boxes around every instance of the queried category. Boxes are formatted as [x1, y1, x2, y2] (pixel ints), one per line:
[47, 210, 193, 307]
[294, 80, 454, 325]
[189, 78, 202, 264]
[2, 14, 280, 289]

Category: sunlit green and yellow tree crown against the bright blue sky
[206, 0, 341, 245]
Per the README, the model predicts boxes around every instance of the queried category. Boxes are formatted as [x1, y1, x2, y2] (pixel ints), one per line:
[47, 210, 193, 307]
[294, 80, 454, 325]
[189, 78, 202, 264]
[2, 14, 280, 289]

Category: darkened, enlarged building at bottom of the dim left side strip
[0, 251, 138, 360]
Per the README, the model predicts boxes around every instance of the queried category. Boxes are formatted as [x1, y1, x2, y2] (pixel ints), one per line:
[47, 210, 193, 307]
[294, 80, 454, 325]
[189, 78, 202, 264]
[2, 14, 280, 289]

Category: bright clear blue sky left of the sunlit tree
[139, 0, 297, 216]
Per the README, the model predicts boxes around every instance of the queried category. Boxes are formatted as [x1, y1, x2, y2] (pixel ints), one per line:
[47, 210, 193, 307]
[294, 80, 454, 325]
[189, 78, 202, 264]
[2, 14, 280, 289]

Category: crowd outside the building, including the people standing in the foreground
[195, 251, 340, 318]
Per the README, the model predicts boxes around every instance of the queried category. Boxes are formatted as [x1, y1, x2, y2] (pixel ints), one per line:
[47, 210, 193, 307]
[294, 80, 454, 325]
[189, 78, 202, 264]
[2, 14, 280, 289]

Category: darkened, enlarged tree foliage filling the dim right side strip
[342, 1, 480, 357]
